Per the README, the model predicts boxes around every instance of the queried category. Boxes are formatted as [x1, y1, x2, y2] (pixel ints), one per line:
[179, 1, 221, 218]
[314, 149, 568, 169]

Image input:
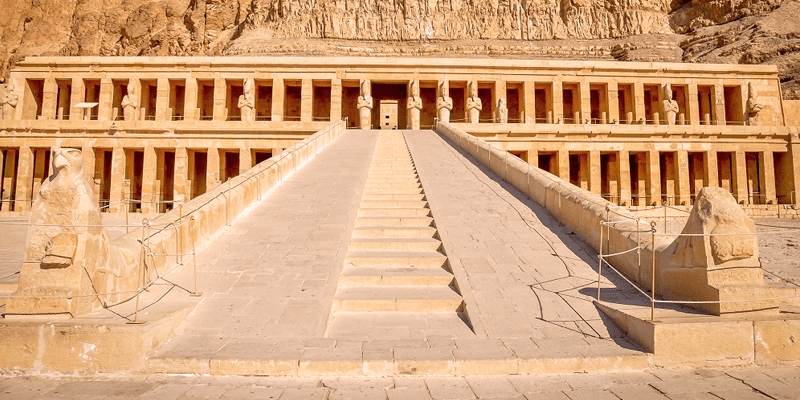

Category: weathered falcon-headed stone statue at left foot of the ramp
[6, 147, 139, 317]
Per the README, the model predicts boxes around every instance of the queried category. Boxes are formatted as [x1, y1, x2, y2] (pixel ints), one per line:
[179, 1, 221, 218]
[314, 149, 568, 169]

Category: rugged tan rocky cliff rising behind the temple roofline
[0, 0, 800, 98]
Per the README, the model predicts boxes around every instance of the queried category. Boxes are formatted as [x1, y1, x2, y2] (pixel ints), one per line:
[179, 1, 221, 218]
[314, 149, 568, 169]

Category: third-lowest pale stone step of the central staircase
[344, 251, 447, 268]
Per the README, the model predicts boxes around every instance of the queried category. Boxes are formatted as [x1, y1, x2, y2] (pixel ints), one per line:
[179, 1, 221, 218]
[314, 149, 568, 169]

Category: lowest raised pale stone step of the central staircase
[333, 286, 462, 312]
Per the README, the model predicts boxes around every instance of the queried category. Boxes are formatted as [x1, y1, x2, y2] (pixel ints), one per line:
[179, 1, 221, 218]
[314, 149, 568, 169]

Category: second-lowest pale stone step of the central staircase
[339, 267, 454, 287]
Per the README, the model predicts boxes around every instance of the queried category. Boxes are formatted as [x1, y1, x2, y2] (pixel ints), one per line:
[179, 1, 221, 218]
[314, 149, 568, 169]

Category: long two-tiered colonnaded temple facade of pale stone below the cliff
[0, 57, 800, 213]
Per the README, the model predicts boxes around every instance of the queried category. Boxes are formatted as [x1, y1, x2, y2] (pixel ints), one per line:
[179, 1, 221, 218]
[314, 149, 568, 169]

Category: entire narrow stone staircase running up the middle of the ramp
[328, 131, 468, 336]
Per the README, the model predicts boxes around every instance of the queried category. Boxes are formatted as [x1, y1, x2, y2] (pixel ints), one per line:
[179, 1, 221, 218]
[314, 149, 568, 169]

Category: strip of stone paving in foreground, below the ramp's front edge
[0, 367, 800, 400]
